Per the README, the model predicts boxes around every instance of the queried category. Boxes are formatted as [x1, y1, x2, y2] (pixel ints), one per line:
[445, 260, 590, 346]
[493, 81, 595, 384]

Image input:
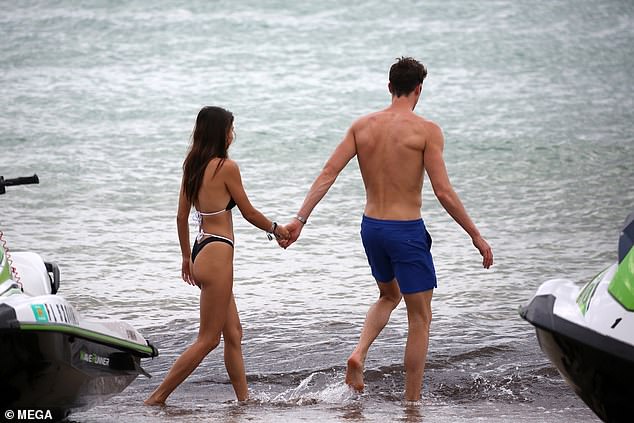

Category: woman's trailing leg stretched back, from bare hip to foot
[145, 242, 233, 405]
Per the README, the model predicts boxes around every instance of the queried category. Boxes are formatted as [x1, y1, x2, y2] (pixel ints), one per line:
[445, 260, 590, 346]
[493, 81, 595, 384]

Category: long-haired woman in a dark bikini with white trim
[145, 107, 289, 405]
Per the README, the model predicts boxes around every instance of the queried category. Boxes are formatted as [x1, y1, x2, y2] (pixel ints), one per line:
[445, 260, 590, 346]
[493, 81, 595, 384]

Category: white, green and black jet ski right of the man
[520, 213, 634, 422]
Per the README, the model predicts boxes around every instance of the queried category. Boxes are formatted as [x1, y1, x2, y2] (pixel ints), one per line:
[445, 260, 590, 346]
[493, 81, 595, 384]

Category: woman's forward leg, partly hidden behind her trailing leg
[222, 295, 249, 401]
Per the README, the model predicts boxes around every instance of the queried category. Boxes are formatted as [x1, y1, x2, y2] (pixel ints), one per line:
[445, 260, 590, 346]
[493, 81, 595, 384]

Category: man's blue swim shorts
[361, 215, 436, 294]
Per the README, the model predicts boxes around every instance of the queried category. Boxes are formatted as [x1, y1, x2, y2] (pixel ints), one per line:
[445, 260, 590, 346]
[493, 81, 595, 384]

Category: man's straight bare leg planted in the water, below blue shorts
[403, 289, 434, 401]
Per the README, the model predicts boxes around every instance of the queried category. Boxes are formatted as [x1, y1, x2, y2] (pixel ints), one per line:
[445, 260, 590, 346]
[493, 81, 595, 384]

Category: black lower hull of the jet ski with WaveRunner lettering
[0, 329, 152, 418]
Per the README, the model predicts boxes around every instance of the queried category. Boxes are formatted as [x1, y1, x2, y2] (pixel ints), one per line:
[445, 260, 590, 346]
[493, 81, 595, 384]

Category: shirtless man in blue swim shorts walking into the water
[280, 57, 493, 401]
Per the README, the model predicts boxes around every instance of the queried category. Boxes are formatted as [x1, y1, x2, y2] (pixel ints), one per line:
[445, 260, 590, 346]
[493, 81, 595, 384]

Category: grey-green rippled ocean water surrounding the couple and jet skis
[0, 0, 634, 423]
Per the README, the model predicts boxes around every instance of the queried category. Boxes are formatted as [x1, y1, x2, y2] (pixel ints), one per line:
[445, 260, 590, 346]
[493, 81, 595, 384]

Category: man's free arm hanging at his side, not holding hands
[423, 123, 493, 269]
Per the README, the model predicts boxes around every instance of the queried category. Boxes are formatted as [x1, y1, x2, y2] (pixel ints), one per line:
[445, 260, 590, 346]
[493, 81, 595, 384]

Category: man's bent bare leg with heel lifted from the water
[346, 279, 401, 391]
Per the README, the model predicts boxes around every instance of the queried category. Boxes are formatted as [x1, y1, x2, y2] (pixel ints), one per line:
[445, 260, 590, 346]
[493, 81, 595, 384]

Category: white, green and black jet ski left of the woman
[0, 175, 158, 420]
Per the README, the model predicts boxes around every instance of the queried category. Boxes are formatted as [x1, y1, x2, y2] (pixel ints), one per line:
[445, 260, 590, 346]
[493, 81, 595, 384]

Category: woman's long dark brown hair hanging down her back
[183, 106, 233, 204]
